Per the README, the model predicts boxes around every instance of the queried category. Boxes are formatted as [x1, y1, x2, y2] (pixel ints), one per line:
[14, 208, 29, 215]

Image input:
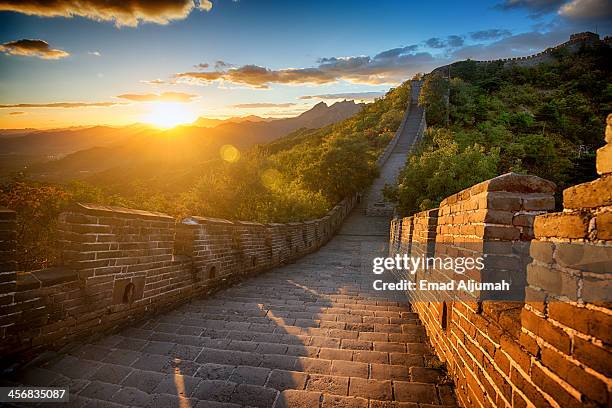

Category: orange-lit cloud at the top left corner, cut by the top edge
[0, 0, 212, 27]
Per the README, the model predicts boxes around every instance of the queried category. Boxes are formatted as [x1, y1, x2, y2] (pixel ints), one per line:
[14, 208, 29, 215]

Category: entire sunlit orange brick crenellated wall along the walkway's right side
[390, 115, 612, 407]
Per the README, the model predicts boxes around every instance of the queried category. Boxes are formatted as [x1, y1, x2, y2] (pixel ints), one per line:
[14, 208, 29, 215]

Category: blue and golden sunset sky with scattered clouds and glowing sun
[0, 0, 612, 129]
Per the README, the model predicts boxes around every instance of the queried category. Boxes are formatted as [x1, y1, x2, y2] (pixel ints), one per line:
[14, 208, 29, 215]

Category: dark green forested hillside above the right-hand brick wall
[386, 43, 612, 215]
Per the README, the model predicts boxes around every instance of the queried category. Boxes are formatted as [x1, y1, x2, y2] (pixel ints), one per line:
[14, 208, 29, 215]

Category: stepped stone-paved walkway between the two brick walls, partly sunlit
[3, 98, 455, 408]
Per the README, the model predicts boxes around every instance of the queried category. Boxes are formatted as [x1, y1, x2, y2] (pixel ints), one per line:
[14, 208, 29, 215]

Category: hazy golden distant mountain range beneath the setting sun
[0, 101, 362, 184]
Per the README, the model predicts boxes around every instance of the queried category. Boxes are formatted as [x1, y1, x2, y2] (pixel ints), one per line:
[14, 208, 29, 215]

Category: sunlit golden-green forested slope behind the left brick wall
[0, 82, 410, 270]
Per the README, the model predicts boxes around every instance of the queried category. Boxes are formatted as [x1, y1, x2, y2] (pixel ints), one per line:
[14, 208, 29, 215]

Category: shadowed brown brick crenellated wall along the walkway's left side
[0, 197, 356, 358]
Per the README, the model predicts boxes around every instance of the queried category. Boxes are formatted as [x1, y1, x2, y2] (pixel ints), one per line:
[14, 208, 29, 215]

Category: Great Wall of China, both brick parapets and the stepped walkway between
[0, 36, 612, 408]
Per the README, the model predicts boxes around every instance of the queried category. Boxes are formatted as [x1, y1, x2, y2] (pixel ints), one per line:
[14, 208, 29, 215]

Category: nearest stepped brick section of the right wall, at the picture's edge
[521, 115, 612, 407]
